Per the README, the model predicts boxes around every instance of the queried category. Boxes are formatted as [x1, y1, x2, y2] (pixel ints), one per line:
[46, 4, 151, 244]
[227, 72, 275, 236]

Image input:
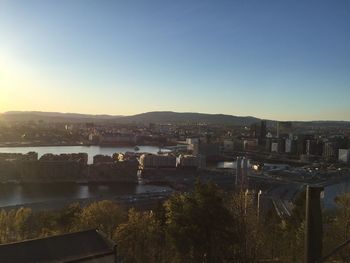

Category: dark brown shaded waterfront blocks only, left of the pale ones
[0, 153, 139, 183]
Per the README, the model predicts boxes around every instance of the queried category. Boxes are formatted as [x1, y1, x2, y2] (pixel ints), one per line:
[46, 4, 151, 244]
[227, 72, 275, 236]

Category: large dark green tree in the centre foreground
[165, 182, 236, 262]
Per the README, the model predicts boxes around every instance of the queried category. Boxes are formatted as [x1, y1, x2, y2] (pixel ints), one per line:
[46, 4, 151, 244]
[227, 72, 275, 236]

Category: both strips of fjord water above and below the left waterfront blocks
[0, 146, 169, 207]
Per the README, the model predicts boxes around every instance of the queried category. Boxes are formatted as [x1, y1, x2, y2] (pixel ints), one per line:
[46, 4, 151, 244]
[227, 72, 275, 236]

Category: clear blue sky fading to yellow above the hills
[0, 0, 350, 120]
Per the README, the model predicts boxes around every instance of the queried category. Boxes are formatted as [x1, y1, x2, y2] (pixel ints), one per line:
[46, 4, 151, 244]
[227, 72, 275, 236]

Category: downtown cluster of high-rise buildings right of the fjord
[184, 120, 350, 166]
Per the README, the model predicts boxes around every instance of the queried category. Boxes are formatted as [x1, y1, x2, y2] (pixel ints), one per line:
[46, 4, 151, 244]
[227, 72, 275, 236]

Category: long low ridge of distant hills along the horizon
[0, 111, 350, 128]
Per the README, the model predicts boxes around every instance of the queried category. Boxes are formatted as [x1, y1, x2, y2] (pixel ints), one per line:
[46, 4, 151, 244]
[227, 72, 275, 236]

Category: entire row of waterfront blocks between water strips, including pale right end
[0, 152, 211, 183]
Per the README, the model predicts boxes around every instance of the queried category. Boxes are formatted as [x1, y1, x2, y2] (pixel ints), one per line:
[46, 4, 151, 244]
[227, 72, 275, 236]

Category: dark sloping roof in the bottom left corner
[0, 229, 114, 263]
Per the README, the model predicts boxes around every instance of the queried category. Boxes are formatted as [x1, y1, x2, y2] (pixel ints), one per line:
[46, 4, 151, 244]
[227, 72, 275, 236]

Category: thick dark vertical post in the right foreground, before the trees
[304, 186, 323, 263]
